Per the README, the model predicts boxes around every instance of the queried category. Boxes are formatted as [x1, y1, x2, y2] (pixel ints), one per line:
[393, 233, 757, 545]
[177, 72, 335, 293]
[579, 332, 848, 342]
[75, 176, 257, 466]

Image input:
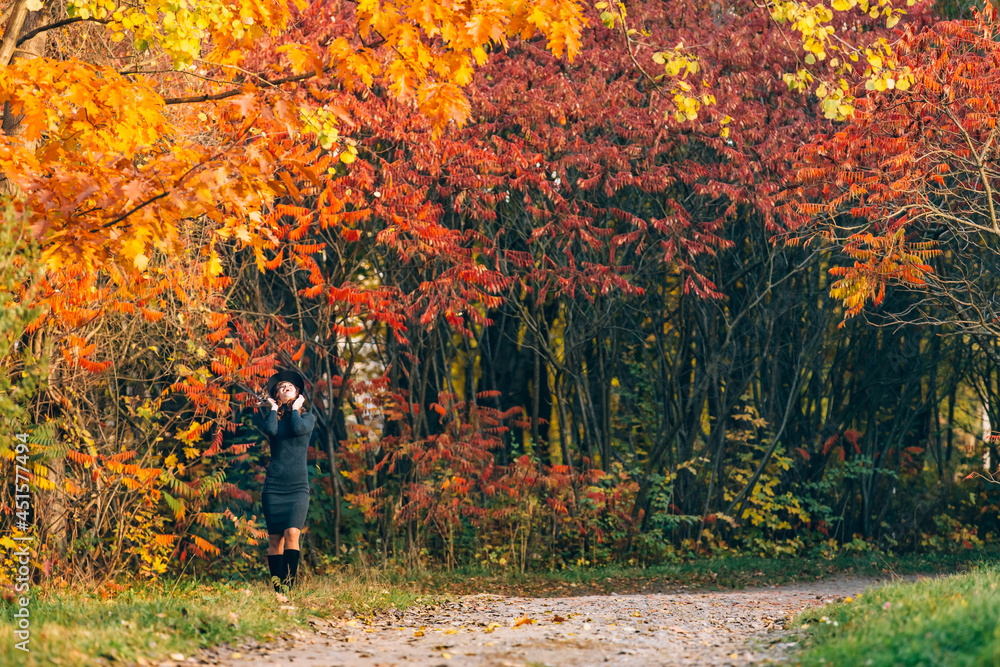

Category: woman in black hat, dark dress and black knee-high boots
[261, 371, 316, 594]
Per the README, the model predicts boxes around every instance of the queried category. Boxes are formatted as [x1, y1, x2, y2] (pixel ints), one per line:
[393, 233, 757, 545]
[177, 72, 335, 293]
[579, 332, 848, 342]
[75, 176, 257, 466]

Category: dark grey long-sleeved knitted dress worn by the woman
[261, 410, 316, 535]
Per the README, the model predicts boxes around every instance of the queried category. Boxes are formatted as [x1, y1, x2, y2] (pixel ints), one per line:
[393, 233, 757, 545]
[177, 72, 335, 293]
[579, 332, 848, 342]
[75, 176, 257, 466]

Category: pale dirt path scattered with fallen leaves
[174, 578, 916, 667]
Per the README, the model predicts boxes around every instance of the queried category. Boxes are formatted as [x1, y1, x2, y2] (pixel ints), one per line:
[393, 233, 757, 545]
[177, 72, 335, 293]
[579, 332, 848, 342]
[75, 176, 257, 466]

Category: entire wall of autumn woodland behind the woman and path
[0, 0, 1000, 586]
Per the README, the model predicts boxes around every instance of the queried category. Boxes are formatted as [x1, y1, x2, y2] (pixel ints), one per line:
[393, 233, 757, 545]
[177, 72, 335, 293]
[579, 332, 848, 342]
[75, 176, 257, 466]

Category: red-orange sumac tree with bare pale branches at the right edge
[788, 4, 1000, 342]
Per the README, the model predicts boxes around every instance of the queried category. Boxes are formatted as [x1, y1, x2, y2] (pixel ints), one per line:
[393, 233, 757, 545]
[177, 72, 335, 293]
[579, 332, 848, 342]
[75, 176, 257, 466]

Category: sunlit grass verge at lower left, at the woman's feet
[0, 573, 420, 667]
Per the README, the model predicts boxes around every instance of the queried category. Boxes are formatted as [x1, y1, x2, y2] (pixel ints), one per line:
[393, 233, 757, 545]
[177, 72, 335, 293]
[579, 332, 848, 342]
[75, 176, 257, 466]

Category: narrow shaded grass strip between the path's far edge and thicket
[387, 554, 984, 597]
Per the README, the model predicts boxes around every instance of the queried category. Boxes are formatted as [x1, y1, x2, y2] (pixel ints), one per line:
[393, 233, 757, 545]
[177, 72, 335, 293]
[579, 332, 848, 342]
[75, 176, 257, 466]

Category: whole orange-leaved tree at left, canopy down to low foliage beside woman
[0, 0, 583, 576]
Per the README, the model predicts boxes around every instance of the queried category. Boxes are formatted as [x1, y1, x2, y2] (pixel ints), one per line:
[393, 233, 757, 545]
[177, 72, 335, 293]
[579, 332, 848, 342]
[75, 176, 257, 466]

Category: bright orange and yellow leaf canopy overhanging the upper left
[0, 0, 585, 360]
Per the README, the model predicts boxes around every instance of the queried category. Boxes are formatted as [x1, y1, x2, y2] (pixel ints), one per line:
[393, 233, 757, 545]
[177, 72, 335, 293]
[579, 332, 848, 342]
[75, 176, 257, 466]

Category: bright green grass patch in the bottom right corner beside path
[793, 559, 1000, 667]
